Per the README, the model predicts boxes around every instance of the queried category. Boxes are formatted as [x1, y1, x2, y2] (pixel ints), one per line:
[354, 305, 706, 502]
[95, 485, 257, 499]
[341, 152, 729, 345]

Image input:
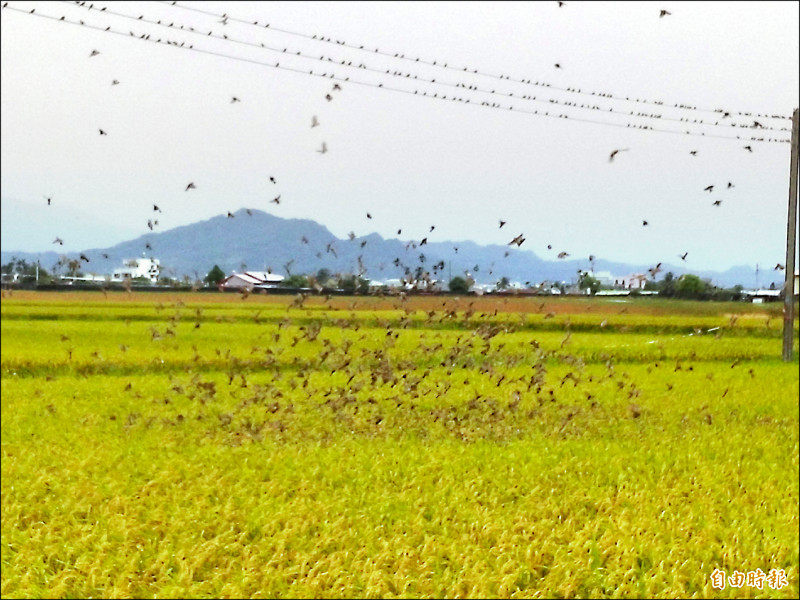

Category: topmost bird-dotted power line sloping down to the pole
[159, 0, 791, 123]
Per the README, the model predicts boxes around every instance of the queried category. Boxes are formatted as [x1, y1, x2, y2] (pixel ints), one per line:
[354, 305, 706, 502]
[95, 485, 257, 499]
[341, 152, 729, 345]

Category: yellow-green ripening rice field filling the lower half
[0, 292, 800, 598]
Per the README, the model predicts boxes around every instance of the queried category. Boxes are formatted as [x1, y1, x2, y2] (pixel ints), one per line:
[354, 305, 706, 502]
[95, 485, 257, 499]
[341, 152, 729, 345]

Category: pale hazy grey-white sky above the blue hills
[0, 1, 800, 269]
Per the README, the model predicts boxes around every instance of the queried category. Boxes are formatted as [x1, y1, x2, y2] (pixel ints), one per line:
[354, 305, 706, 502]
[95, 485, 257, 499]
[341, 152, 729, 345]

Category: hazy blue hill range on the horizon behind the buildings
[0, 209, 782, 287]
